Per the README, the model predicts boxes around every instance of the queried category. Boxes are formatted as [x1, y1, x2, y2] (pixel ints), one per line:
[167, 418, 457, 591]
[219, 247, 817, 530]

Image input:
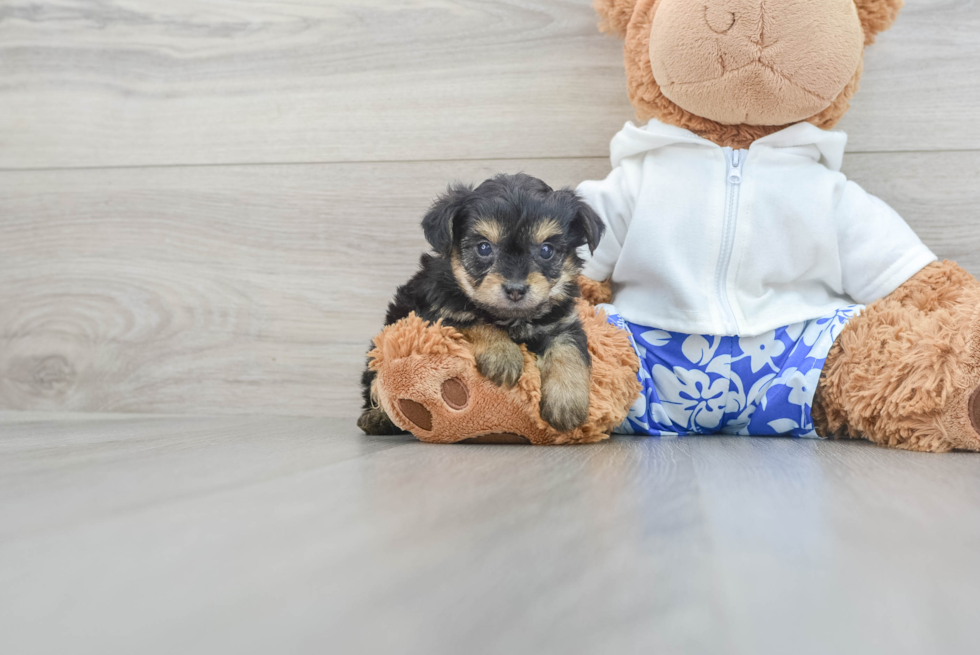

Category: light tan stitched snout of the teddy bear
[649, 0, 864, 125]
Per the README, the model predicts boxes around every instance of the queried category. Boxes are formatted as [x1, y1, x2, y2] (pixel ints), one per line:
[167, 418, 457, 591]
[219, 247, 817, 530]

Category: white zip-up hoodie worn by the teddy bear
[578, 120, 936, 336]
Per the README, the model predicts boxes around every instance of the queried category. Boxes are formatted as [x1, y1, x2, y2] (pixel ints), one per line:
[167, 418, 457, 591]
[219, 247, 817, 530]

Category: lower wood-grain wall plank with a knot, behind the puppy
[0, 152, 980, 415]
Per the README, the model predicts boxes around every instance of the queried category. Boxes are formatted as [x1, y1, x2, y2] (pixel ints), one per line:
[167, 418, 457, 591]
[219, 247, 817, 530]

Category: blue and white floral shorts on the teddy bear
[599, 305, 863, 437]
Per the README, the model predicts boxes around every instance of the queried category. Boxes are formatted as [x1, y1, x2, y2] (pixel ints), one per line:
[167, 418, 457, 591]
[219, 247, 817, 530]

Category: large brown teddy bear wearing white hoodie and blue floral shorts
[371, 0, 980, 452]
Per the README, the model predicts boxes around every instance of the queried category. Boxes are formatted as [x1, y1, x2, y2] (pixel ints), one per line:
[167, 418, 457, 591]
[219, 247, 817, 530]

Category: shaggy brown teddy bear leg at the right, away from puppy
[813, 262, 980, 452]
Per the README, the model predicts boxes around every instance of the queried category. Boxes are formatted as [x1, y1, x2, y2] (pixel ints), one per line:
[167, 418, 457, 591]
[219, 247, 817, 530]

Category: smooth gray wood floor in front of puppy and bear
[0, 414, 980, 655]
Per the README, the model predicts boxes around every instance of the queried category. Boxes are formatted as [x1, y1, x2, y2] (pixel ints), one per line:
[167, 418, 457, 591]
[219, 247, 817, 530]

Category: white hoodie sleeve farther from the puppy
[836, 181, 936, 304]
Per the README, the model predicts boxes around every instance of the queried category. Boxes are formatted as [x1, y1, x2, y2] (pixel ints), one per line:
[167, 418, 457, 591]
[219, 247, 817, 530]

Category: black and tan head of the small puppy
[422, 174, 604, 319]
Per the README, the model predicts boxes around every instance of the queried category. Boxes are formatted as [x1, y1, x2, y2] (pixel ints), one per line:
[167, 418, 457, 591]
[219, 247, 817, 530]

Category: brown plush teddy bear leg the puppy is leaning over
[369, 300, 640, 444]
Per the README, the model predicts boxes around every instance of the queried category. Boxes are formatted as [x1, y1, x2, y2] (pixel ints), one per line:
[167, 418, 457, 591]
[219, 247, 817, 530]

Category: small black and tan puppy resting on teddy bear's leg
[357, 174, 603, 434]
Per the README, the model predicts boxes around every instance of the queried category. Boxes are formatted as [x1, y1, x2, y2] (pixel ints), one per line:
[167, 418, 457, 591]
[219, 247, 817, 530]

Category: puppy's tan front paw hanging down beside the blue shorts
[538, 337, 591, 432]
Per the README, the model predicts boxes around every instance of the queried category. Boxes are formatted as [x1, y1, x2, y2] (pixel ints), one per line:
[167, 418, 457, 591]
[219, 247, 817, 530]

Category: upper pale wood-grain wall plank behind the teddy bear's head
[0, 0, 980, 168]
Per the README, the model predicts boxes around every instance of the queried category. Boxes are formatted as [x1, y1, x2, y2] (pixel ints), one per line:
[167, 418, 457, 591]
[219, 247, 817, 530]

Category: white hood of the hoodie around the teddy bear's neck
[609, 119, 847, 171]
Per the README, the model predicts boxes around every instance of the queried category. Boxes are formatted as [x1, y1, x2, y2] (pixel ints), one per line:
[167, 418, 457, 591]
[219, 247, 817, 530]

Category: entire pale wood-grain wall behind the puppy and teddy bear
[0, 0, 980, 415]
